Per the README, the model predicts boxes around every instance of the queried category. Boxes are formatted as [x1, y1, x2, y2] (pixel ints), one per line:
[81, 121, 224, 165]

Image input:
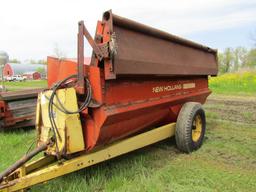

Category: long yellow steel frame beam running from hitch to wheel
[0, 123, 176, 192]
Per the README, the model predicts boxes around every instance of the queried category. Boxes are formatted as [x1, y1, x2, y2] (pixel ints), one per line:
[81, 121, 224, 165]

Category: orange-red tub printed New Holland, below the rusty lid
[48, 57, 211, 150]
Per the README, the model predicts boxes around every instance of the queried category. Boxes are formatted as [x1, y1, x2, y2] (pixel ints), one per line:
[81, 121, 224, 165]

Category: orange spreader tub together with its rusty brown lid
[48, 12, 217, 150]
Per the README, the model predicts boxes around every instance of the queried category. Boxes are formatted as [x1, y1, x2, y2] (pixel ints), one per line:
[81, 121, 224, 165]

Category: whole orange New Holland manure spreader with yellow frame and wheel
[0, 11, 217, 191]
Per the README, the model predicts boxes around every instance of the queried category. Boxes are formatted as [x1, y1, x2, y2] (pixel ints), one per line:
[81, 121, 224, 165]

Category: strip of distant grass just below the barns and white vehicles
[1, 80, 47, 91]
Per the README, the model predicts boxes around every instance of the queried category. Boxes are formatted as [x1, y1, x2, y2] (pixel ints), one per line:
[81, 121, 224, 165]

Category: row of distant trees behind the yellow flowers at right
[218, 47, 256, 74]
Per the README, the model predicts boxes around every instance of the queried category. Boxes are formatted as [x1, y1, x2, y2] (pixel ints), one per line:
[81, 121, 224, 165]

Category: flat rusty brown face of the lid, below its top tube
[114, 26, 217, 76]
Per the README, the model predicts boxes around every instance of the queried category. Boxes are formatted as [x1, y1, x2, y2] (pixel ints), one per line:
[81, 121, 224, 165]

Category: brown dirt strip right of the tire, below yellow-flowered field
[205, 95, 256, 124]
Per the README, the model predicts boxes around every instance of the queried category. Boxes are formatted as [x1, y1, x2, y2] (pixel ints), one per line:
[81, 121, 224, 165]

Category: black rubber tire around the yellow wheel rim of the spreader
[175, 102, 206, 153]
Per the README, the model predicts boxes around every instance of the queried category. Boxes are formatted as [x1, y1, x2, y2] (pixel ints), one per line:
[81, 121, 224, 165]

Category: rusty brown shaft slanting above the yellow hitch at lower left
[0, 142, 50, 183]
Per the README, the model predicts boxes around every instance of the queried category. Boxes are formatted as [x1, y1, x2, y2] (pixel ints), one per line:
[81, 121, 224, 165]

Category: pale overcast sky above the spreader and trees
[0, 0, 256, 60]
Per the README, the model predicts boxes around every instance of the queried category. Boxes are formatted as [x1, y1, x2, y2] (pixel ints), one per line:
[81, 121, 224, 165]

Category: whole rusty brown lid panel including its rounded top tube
[103, 11, 218, 79]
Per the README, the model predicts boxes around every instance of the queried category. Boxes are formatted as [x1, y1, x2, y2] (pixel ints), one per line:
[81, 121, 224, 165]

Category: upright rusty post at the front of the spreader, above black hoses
[77, 21, 84, 94]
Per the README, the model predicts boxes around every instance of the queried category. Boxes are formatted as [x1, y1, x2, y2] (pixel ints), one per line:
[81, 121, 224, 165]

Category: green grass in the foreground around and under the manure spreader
[0, 111, 256, 192]
